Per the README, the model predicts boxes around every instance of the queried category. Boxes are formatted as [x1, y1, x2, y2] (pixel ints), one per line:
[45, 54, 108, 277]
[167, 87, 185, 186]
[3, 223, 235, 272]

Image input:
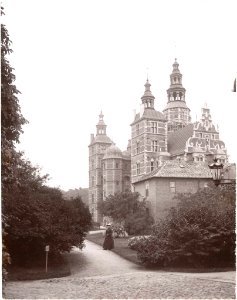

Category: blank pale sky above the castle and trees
[2, 0, 237, 190]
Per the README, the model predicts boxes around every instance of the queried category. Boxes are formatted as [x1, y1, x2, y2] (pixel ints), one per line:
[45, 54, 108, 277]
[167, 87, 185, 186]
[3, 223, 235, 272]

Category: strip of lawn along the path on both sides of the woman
[86, 232, 140, 264]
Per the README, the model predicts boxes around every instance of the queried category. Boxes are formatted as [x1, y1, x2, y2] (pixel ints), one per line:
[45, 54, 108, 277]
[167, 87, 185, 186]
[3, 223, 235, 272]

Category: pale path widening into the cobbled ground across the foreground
[6, 241, 235, 299]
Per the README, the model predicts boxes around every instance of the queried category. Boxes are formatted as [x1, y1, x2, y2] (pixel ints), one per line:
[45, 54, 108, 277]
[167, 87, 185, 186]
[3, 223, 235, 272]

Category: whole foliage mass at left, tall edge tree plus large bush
[1, 8, 91, 268]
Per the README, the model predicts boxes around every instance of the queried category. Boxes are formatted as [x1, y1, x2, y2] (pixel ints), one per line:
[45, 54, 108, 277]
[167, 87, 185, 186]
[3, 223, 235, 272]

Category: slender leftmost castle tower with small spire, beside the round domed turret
[88, 112, 113, 222]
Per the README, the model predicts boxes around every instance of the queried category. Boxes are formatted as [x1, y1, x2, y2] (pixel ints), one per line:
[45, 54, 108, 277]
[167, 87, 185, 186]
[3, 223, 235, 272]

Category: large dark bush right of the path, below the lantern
[137, 188, 235, 267]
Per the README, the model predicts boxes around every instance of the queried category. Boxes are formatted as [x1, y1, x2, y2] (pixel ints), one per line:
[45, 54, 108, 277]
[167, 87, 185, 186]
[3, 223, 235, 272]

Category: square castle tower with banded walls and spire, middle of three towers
[131, 79, 169, 183]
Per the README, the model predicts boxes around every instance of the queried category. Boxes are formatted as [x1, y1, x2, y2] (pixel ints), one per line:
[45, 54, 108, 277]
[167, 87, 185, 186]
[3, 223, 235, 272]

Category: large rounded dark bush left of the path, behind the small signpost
[5, 186, 91, 264]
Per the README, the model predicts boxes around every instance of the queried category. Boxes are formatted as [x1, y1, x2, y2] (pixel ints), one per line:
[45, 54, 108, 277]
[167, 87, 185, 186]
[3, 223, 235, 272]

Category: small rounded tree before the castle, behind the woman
[98, 192, 153, 235]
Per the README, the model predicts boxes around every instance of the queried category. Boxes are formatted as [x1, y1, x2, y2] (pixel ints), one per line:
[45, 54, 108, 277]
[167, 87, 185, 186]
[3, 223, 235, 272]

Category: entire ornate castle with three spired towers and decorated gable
[89, 59, 228, 223]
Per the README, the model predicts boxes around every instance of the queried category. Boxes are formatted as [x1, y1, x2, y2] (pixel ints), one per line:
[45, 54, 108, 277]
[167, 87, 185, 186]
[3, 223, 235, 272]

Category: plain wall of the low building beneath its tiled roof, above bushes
[134, 178, 212, 220]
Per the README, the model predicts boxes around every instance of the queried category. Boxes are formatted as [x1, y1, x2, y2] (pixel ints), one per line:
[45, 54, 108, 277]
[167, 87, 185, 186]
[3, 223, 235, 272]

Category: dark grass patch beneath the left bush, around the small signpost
[7, 256, 71, 281]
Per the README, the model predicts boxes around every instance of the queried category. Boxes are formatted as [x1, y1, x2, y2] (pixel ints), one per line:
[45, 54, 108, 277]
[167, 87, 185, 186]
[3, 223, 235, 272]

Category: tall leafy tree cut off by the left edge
[1, 6, 27, 279]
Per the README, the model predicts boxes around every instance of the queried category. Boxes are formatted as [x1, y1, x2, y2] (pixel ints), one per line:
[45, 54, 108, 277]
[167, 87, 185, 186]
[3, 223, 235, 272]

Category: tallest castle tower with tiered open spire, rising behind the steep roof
[163, 59, 191, 133]
